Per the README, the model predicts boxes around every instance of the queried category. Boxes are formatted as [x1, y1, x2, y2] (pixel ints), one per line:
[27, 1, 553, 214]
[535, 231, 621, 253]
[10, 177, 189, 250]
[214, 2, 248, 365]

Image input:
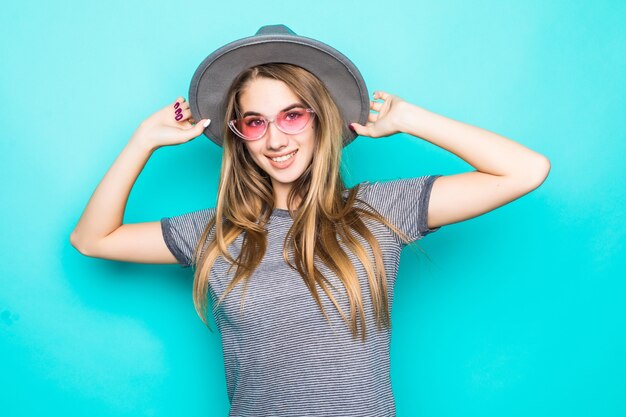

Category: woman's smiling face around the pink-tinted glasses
[239, 78, 315, 200]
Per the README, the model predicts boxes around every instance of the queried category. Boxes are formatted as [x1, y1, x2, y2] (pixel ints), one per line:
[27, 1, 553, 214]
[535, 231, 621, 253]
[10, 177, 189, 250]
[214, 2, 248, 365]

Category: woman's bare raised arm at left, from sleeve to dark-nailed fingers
[70, 97, 210, 263]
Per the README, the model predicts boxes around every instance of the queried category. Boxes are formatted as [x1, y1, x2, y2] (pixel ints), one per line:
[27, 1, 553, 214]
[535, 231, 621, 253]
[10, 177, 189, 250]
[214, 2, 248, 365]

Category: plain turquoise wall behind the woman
[0, 0, 626, 417]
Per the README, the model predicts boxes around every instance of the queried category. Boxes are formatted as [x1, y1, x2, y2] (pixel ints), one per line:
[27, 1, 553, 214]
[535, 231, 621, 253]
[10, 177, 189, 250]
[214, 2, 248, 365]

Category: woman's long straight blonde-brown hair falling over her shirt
[192, 64, 408, 340]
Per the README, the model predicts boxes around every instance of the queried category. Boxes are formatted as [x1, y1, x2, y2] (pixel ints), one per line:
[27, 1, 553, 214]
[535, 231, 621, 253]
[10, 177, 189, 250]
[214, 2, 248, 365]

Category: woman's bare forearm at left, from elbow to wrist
[70, 136, 155, 247]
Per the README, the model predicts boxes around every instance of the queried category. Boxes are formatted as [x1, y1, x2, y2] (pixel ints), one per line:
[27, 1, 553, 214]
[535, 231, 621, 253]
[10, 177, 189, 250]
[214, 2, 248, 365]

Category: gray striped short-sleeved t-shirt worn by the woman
[161, 175, 439, 417]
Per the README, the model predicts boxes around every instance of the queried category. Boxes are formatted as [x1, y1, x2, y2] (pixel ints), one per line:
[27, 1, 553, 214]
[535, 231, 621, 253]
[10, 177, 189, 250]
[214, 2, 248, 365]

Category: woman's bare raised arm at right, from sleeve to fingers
[352, 91, 550, 228]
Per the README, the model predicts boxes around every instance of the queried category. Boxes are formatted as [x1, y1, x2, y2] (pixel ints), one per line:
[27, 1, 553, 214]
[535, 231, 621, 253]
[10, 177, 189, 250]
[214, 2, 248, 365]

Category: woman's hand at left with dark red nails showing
[131, 97, 211, 149]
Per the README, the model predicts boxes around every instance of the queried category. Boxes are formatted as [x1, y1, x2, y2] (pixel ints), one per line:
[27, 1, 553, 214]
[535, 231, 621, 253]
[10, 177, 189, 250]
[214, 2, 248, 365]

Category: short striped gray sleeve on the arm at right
[358, 175, 441, 241]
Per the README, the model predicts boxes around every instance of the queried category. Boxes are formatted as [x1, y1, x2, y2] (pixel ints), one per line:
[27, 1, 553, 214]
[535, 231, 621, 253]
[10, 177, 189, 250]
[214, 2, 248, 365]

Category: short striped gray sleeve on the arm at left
[161, 208, 215, 268]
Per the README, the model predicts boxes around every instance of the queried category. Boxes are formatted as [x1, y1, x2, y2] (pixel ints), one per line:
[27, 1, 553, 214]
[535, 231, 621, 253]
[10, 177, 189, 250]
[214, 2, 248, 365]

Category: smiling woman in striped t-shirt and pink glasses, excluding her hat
[71, 25, 550, 416]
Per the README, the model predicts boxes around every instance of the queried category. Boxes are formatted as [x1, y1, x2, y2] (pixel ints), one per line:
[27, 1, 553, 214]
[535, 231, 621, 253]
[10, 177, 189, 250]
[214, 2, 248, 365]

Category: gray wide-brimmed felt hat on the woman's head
[189, 25, 369, 146]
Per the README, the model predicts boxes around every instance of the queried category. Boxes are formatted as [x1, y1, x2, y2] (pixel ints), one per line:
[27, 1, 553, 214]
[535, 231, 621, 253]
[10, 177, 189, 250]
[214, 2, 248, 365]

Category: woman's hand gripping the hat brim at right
[350, 91, 409, 138]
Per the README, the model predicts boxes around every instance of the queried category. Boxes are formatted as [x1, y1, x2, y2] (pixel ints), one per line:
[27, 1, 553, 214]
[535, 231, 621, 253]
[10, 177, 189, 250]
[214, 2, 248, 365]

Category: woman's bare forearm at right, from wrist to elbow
[398, 103, 549, 178]
